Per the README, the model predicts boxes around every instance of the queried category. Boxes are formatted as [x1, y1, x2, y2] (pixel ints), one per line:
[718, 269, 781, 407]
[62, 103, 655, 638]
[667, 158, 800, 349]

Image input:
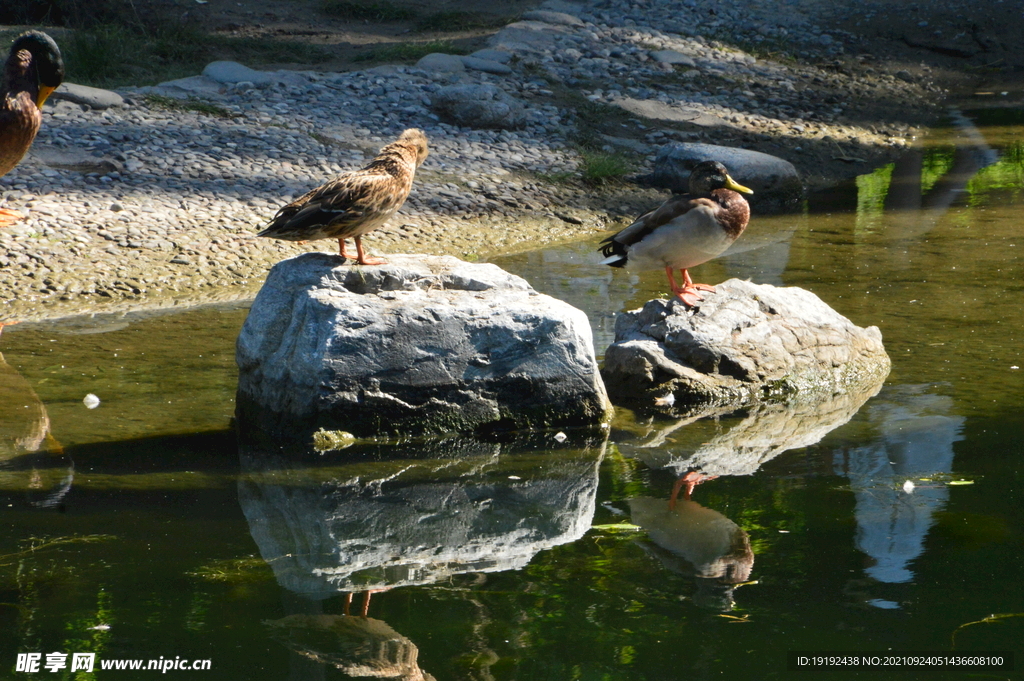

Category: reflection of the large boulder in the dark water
[239, 436, 604, 598]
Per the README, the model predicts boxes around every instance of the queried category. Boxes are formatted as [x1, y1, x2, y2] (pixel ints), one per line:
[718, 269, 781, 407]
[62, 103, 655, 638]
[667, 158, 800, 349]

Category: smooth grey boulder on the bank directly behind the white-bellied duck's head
[650, 142, 804, 213]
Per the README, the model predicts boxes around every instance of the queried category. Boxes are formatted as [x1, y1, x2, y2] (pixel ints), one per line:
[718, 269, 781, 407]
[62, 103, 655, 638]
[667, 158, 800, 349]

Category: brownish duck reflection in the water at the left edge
[0, 353, 75, 508]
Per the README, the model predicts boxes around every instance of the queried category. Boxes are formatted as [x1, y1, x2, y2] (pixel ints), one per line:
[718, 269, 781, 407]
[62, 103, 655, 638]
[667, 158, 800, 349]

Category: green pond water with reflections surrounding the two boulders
[0, 114, 1024, 680]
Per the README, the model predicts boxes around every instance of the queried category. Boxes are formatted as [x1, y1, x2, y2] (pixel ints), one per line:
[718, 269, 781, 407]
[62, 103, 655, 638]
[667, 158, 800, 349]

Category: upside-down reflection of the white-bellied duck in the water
[630, 497, 754, 612]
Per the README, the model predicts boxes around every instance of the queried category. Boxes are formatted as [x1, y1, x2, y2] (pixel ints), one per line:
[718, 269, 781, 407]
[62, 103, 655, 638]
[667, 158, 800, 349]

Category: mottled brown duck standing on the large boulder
[256, 128, 429, 265]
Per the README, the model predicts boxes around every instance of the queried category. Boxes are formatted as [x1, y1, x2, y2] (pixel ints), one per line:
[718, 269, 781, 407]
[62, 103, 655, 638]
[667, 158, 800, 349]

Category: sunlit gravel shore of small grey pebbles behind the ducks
[0, 0, 962, 322]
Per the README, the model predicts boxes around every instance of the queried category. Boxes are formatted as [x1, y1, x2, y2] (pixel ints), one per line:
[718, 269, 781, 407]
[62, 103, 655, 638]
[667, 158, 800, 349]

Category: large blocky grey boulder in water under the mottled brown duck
[237, 253, 610, 435]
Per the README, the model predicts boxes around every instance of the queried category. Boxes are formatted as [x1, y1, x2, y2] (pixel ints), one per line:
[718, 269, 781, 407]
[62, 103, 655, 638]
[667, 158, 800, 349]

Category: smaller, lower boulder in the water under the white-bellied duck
[602, 280, 891, 413]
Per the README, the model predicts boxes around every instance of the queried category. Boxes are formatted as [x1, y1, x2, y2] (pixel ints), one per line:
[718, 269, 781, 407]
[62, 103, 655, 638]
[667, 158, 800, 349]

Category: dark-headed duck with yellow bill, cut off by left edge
[0, 31, 63, 226]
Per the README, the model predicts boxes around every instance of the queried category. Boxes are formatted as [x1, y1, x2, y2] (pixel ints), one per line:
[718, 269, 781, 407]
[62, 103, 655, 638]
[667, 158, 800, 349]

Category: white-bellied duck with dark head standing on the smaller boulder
[601, 161, 754, 307]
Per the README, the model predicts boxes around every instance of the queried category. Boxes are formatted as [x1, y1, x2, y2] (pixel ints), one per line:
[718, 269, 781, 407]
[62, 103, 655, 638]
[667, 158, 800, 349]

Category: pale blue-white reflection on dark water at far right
[834, 385, 965, 585]
